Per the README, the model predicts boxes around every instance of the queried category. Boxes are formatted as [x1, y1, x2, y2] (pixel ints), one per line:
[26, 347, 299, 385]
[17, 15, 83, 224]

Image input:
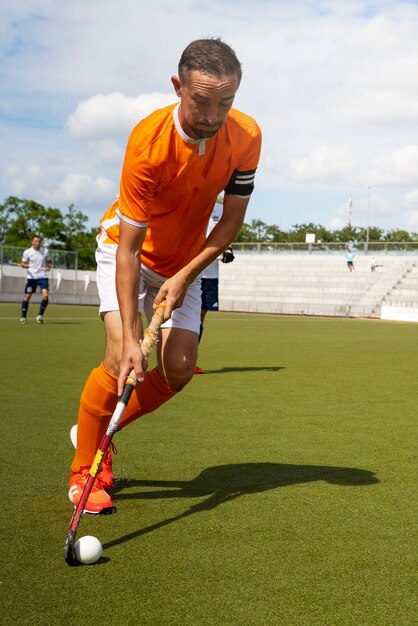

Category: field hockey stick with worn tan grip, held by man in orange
[64, 301, 166, 565]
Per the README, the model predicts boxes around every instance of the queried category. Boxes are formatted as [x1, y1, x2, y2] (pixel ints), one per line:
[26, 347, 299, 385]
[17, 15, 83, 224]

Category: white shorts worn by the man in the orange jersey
[96, 243, 202, 334]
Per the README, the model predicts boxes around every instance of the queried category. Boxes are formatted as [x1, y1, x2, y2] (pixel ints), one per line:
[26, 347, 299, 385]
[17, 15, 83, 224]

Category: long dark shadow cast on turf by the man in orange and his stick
[103, 463, 379, 549]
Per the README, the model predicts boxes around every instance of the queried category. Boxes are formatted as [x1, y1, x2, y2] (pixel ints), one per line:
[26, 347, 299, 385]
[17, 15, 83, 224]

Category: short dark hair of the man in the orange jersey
[178, 37, 242, 84]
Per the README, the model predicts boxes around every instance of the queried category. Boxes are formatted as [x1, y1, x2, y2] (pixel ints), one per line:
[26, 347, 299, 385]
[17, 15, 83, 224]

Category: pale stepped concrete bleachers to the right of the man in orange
[219, 253, 418, 317]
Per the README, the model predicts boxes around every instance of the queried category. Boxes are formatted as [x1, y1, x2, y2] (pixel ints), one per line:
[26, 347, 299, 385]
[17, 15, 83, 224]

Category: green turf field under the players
[0, 304, 418, 626]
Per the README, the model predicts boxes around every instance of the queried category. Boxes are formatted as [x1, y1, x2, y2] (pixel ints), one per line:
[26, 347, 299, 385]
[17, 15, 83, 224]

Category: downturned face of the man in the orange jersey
[171, 70, 239, 139]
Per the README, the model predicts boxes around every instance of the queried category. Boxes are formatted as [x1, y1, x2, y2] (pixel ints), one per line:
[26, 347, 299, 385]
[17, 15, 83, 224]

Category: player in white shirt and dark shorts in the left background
[19, 235, 52, 324]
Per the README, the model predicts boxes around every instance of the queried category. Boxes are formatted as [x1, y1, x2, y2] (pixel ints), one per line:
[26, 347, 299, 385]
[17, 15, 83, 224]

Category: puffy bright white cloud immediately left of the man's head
[67, 91, 177, 139]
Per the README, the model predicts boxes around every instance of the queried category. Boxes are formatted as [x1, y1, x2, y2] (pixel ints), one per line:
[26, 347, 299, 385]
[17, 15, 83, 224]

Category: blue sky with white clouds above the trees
[0, 0, 418, 231]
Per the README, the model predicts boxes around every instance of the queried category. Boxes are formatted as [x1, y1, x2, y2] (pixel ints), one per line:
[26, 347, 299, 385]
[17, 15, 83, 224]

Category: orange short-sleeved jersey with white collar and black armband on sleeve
[99, 104, 261, 276]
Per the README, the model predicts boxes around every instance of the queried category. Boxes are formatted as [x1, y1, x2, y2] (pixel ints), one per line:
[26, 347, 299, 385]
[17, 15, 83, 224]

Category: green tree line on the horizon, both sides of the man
[0, 196, 418, 270]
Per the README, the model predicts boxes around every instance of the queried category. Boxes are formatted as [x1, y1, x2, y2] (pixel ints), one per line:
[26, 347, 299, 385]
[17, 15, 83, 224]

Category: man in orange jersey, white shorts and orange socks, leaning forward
[69, 39, 261, 513]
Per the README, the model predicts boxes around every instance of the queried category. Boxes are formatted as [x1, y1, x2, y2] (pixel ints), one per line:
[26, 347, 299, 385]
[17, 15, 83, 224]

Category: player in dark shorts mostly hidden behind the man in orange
[194, 197, 235, 374]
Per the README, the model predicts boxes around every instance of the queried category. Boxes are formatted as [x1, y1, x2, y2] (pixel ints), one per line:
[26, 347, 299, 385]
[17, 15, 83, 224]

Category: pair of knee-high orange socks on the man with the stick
[71, 363, 177, 472]
